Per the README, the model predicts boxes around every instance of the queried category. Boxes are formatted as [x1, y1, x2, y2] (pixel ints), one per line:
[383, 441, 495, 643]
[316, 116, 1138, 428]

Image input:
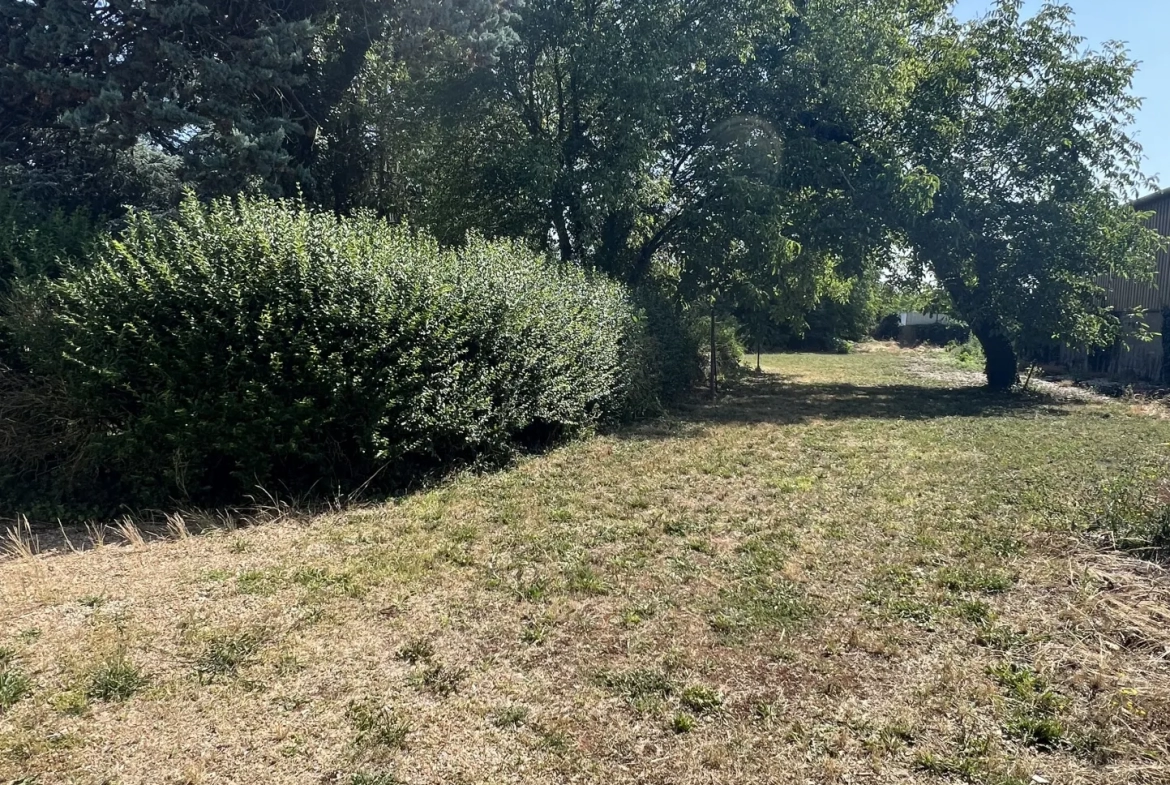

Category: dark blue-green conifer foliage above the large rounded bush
[0, 0, 517, 208]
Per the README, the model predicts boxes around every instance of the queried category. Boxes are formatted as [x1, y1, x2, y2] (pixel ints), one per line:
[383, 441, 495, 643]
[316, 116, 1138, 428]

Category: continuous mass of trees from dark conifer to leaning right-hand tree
[0, 0, 1157, 387]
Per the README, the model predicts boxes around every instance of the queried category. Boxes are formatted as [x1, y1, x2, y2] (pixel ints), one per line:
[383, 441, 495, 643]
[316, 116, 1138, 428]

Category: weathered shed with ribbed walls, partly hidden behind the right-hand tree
[1061, 188, 1170, 381]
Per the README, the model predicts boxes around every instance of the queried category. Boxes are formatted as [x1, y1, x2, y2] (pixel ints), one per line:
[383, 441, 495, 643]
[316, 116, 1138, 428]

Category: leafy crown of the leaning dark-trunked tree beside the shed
[902, 0, 1161, 384]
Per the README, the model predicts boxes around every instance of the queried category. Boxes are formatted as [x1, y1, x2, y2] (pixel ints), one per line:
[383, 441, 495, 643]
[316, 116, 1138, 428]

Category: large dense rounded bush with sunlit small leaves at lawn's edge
[0, 198, 661, 508]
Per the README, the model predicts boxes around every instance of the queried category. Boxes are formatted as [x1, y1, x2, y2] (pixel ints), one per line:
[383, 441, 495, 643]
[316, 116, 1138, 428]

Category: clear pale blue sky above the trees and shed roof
[955, 0, 1170, 194]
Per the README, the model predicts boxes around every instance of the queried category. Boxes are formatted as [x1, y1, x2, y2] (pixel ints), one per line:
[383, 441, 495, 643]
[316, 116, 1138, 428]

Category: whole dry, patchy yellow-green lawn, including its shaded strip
[0, 345, 1170, 785]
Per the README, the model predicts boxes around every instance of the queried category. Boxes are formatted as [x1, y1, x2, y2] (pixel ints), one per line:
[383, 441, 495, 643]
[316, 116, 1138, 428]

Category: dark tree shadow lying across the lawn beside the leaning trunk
[615, 373, 1083, 439]
